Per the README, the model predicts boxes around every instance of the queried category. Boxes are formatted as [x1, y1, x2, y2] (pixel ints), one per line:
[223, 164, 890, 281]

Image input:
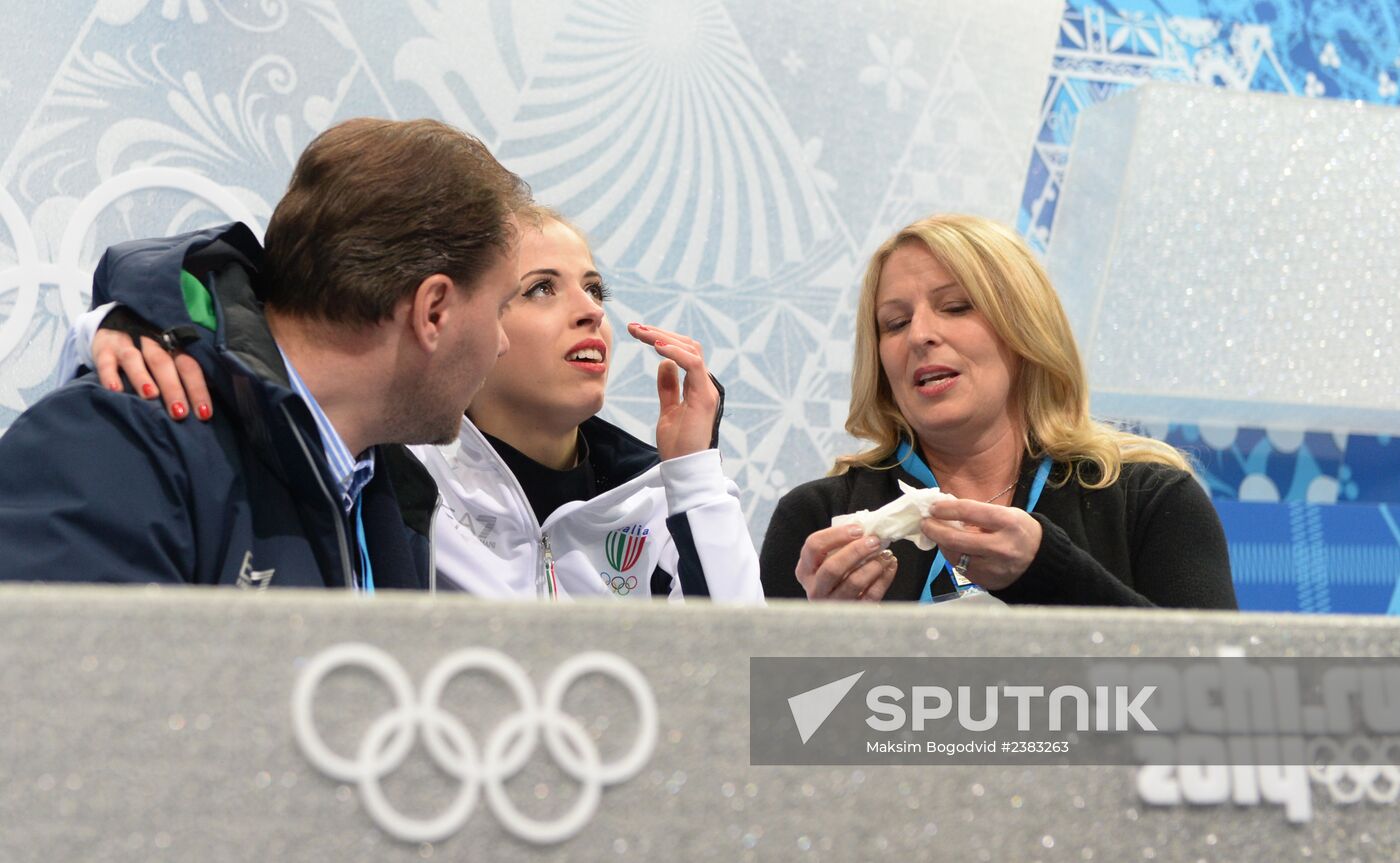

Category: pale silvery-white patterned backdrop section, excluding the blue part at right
[0, 0, 1061, 537]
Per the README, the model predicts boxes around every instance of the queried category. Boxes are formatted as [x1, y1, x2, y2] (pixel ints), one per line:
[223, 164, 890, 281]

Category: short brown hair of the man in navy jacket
[262, 118, 529, 325]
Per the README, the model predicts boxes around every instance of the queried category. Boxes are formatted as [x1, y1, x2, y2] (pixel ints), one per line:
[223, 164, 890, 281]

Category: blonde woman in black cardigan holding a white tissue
[762, 216, 1235, 608]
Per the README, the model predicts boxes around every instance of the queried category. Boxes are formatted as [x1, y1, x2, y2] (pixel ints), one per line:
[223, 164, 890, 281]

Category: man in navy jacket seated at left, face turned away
[0, 119, 529, 591]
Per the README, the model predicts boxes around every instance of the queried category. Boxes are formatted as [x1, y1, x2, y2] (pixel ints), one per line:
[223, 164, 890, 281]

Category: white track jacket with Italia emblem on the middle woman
[412, 417, 763, 604]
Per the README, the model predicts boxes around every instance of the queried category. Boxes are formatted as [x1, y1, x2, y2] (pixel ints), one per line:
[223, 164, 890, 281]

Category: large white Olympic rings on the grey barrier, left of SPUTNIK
[291, 643, 657, 845]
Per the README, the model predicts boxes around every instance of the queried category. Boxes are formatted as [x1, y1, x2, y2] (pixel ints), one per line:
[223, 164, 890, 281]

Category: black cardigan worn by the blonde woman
[760, 458, 1236, 608]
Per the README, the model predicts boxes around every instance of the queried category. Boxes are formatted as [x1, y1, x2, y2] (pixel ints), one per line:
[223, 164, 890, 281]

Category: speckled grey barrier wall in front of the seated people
[0, 587, 1400, 863]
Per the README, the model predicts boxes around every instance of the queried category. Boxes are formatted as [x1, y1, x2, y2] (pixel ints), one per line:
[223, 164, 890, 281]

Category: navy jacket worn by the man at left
[0, 224, 437, 588]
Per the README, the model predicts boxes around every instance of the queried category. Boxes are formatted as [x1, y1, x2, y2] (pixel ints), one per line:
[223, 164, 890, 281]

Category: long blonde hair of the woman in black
[832, 216, 1191, 489]
